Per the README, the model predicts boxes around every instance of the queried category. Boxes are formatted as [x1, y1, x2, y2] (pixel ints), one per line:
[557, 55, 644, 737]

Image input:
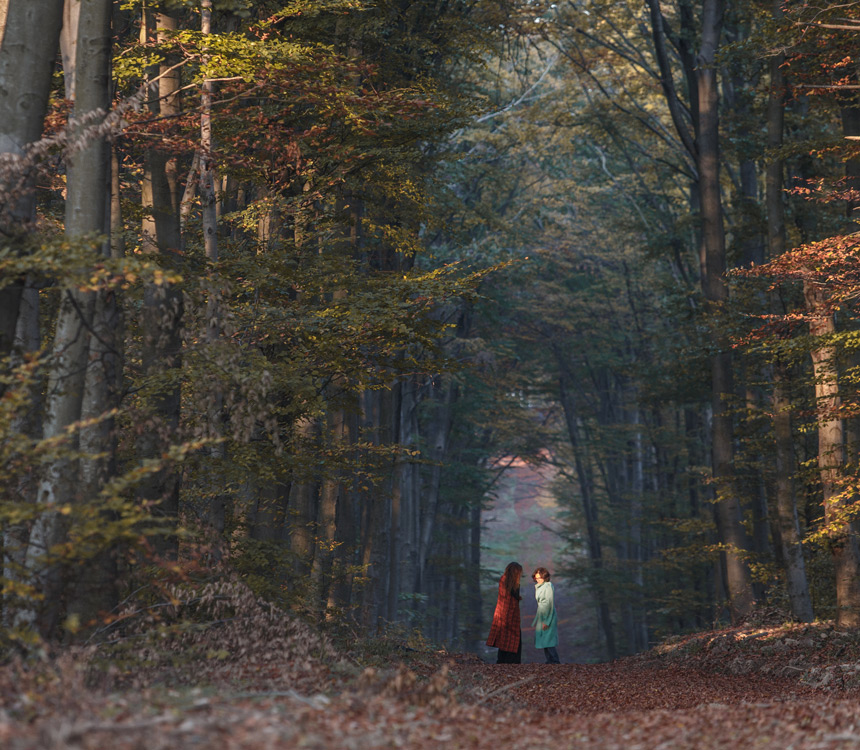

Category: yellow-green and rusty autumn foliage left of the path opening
[0, 0, 506, 652]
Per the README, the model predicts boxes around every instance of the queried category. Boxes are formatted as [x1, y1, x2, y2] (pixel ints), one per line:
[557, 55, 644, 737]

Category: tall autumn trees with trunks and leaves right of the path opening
[460, 0, 860, 657]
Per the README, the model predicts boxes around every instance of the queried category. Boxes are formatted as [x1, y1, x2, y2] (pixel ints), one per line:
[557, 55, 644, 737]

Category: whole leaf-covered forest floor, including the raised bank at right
[5, 624, 860, 750]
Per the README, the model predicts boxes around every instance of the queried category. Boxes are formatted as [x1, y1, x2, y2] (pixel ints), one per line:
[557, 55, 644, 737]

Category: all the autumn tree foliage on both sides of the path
[15, 0, 860, 661]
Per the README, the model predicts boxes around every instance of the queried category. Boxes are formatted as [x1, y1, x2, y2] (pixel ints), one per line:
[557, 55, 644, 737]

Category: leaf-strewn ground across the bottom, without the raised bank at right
[0, 659, 860, 750]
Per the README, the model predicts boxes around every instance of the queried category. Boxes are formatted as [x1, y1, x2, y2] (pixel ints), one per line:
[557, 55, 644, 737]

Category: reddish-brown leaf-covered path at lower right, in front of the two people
[450, 659, 860, 750]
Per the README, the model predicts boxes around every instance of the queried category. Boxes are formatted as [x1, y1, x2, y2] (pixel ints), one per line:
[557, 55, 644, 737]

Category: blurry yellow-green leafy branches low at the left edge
[0, 355, 213, 649]
